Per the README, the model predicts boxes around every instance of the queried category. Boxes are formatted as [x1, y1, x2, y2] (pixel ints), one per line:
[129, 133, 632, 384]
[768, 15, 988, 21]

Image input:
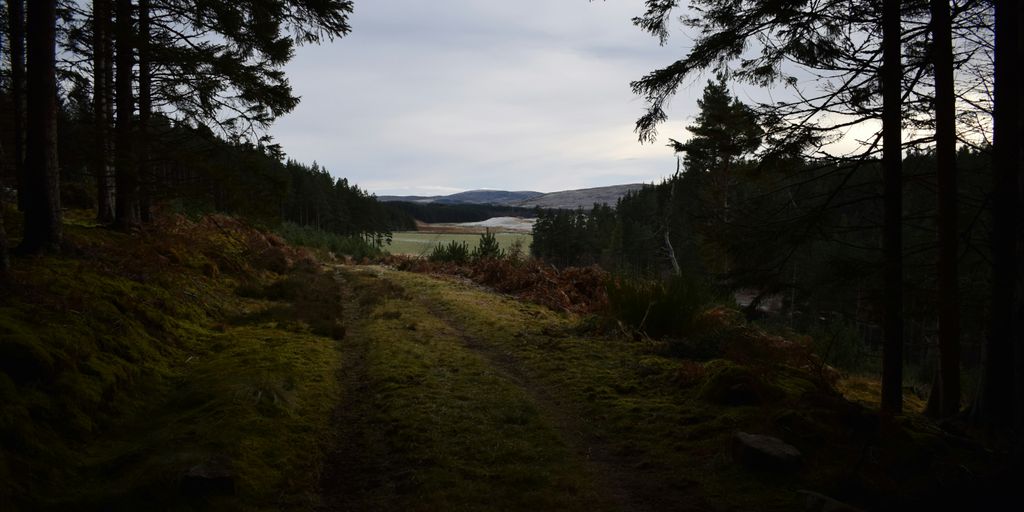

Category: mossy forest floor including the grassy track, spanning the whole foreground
[0, 209, 1005, 511]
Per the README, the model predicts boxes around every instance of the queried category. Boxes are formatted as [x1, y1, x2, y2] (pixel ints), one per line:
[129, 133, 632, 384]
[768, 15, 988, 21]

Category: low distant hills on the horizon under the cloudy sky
[377, 183, 643, 210]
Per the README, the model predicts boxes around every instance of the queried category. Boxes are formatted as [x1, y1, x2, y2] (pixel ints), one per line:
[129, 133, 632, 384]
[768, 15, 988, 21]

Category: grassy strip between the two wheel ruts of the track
[327, 268, 607, 510]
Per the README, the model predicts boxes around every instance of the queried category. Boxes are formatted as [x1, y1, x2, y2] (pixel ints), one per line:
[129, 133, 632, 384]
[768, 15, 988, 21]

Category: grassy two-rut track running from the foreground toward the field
[321, 267, 709, 511]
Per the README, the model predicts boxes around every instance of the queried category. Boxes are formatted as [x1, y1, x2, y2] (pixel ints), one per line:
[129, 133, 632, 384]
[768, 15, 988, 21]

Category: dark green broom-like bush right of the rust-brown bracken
[607, 275, 711, 338]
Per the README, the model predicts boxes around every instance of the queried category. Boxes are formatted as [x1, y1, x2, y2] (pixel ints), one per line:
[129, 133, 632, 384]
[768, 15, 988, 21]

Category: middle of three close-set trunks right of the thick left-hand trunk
[114, 0, 142, 229]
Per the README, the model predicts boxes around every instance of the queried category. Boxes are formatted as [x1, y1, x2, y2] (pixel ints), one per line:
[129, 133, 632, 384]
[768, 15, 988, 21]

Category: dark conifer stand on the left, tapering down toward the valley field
[0, 0, 413, 256]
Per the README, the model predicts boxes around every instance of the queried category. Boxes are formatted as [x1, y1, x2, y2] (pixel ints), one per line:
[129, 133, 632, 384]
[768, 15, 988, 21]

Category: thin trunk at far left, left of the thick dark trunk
[7, 0, 27, 211]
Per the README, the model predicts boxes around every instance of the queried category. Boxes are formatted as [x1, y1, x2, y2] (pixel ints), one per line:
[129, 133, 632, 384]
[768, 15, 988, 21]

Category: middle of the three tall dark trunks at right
[929, 0, 961, 418]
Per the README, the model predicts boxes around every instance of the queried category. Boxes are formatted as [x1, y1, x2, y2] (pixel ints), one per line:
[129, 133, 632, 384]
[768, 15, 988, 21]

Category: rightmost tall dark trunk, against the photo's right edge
[974, 0, 1024, 429]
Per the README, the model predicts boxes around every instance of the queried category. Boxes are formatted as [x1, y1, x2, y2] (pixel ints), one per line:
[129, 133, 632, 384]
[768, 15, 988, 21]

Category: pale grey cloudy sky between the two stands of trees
[271, 0, 712, 195]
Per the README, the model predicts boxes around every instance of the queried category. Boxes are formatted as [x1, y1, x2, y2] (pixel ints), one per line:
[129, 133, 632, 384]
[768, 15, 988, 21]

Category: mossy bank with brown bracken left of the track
[0, 207, 344, 510]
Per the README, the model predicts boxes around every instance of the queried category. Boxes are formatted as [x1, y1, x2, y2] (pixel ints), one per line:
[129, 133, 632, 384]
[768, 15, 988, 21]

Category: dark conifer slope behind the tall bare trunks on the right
[531, 148, 991, 358]
